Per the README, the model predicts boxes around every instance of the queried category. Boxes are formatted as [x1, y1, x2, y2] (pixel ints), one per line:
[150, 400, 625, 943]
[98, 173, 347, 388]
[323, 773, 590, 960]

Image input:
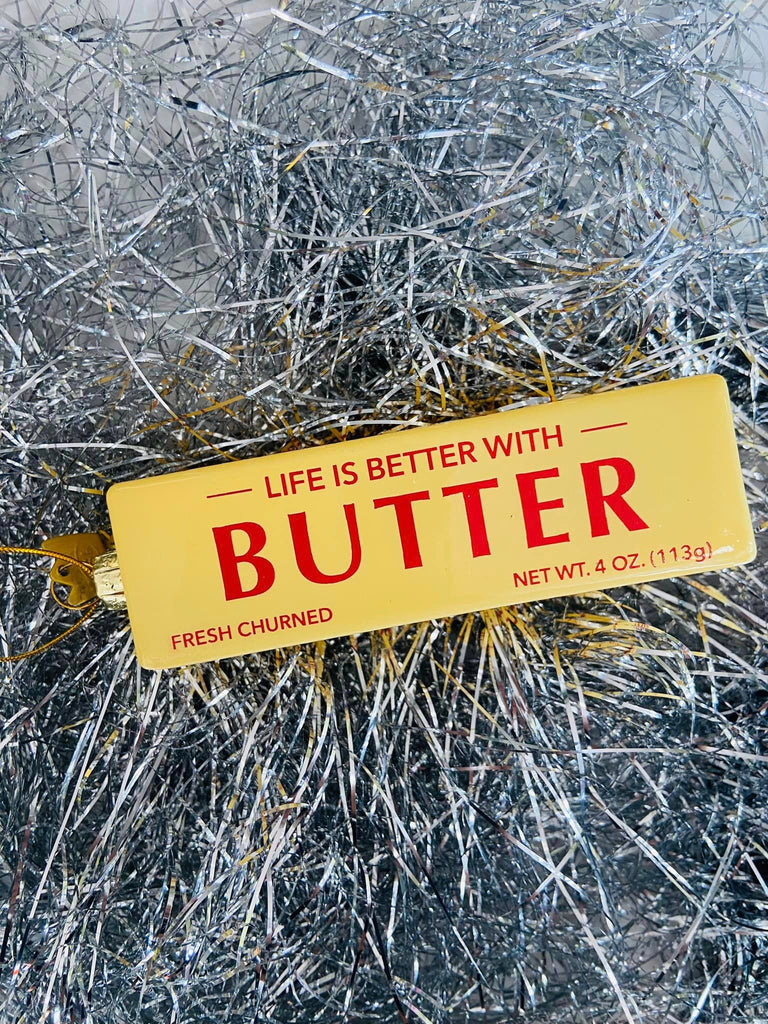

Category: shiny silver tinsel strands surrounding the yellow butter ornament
[0, 0, 768, 1024]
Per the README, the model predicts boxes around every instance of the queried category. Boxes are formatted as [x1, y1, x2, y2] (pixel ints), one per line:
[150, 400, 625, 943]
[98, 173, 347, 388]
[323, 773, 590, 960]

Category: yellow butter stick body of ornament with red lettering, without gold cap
[108, 376, 755, 669]
